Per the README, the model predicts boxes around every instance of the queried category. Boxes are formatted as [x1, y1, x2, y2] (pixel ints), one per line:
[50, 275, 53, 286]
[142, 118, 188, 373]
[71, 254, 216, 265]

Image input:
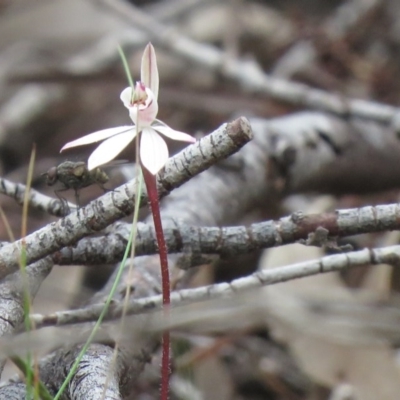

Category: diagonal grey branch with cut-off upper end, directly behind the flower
[0, 118, 252, 277]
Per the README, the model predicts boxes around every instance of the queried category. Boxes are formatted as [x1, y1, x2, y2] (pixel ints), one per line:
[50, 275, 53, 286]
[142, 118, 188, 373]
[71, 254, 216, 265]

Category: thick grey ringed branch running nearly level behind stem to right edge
[52, 203, 400, 267]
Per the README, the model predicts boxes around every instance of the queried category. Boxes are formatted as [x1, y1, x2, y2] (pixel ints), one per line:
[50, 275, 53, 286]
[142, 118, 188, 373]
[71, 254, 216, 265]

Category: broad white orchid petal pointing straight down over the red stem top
[140, 128, 168, 175]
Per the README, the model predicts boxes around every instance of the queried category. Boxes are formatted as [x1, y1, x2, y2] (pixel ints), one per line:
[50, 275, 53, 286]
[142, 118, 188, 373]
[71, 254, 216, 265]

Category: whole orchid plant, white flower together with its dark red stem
[61, 43, 195, 400]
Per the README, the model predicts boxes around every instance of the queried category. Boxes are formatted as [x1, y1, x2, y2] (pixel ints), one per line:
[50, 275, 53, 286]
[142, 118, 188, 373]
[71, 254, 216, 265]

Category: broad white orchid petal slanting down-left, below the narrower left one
[88, 127, 136, 170]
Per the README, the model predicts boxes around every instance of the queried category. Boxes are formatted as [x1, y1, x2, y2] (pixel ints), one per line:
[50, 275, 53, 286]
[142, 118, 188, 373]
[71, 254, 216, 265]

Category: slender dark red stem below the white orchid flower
[142, 166, 171, 400]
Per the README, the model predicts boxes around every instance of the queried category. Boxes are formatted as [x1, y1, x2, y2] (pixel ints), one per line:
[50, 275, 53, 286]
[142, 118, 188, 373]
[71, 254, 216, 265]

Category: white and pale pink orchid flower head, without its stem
[61, 43, 196, 175]
